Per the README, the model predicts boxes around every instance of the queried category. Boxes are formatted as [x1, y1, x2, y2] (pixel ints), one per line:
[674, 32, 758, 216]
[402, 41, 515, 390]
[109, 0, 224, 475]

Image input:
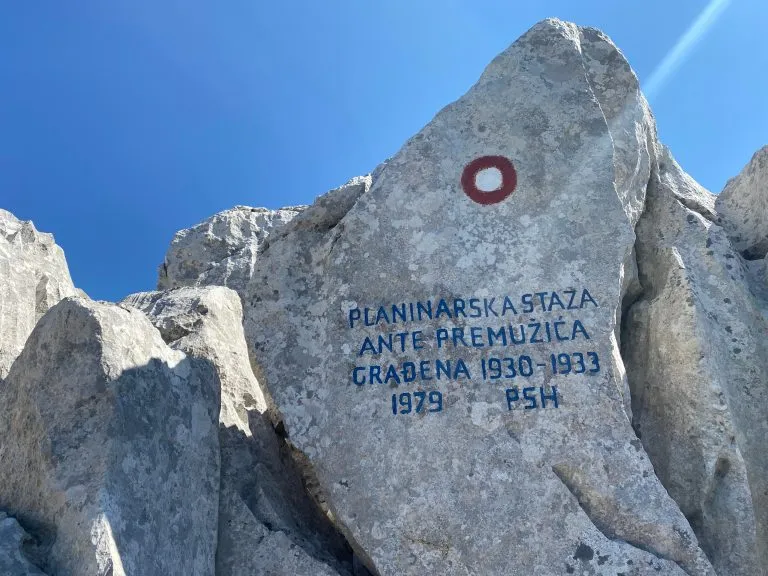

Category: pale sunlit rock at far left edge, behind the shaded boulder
[0, 209, 76, 380]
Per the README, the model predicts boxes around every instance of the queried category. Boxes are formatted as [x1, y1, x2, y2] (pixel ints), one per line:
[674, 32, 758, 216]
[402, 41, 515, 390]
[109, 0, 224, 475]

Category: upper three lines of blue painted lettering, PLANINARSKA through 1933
[344, 288, 600, 409]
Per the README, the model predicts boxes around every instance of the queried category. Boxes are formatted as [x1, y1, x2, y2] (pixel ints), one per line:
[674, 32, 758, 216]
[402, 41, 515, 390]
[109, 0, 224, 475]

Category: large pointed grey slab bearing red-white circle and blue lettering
[245, 20, 714, 576]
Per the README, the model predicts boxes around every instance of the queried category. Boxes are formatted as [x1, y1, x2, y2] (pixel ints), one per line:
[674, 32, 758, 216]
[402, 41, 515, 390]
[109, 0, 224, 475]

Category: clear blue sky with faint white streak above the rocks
[0, 0, 768, 300]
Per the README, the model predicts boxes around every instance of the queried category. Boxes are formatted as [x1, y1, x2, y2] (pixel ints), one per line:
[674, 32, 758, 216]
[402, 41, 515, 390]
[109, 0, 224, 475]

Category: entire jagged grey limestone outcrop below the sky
[0, 20, 768, 576]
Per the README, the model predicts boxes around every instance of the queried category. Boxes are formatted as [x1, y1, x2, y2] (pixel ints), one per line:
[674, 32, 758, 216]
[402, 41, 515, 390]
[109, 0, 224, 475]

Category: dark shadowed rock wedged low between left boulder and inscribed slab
[216, 413, 353, 576]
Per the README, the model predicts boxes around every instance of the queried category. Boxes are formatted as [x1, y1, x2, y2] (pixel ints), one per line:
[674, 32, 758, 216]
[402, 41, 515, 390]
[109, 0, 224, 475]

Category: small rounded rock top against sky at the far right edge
[716, 146, 768, 259]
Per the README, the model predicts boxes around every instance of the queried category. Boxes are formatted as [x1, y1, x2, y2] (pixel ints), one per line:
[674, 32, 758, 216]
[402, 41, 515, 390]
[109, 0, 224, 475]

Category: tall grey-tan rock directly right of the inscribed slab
[622, 145, 768, 576]
